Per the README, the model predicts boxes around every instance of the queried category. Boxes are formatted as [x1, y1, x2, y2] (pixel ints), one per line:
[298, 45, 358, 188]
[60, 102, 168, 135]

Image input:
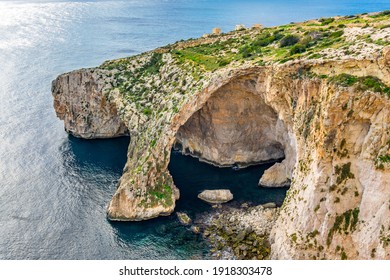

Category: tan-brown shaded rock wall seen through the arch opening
[174, 77, 288, 173]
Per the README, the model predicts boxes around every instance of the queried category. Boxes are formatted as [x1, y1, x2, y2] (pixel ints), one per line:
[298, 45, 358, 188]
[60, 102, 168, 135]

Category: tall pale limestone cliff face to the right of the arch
[271, 55, 390, 259]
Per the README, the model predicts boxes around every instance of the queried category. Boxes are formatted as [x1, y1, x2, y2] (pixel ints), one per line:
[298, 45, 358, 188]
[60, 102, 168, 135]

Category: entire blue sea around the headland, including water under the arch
[0, 0, 390, 259]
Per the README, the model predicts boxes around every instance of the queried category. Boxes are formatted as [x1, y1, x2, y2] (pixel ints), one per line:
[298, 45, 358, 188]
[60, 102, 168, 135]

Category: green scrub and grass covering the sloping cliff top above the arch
[102, 11, 390, 71]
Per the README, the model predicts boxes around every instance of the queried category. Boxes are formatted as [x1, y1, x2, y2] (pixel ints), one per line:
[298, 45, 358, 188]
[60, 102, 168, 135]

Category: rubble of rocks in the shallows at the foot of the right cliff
[178, 202, 279, 260]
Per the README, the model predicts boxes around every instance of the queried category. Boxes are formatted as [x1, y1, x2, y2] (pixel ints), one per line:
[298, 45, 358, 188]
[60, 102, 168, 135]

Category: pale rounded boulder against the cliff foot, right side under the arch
[259, 162, 291, 188]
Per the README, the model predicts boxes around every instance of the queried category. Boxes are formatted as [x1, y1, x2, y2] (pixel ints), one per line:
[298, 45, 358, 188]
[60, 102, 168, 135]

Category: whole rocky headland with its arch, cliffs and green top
[53, 12, 390, 259]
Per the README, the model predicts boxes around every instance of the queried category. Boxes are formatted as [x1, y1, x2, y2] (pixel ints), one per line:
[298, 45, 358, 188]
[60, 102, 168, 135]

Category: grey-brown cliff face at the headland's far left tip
[52, 69, 128, 138]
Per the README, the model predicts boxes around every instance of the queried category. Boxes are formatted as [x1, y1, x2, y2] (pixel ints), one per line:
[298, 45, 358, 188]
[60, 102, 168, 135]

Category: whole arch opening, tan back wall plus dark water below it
[169, 77, 291, 213]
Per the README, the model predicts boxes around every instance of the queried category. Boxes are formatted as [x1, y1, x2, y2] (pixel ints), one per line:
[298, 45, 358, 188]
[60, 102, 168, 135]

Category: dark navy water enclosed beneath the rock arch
[168, 151, 287, 216]
